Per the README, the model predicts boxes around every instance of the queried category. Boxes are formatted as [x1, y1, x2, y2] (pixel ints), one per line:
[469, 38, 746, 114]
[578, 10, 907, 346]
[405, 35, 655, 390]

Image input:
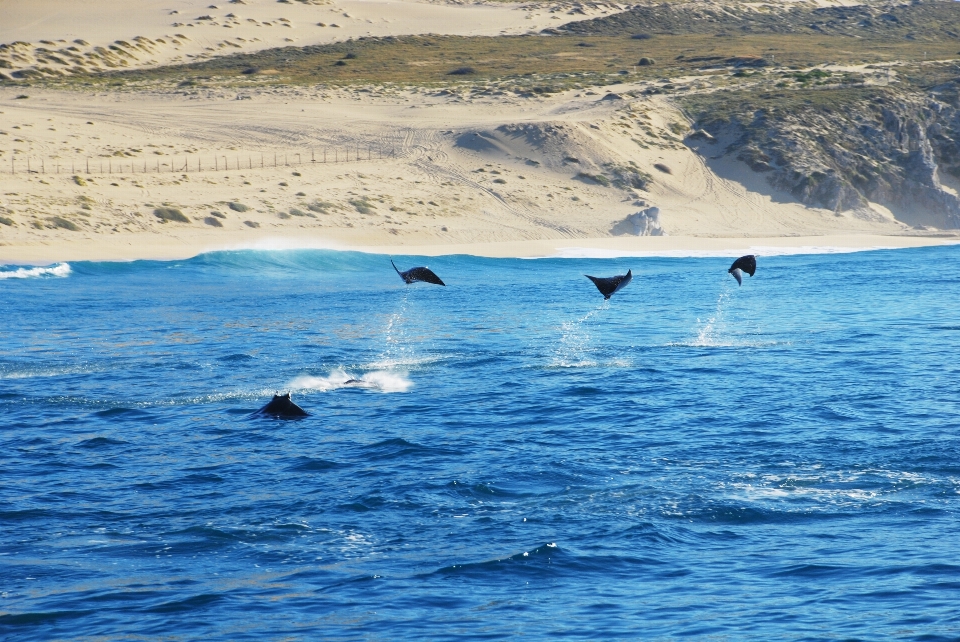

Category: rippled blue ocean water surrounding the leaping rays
[0, 247, 960, 640]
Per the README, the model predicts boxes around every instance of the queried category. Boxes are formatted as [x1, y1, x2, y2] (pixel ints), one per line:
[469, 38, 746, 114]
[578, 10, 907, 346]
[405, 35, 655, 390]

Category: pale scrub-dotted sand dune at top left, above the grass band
[0, 0, 620, 79]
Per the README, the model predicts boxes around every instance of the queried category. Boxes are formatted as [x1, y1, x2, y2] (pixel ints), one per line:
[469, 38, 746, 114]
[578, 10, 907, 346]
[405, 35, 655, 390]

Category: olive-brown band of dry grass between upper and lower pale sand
[18, 33, 958, 96]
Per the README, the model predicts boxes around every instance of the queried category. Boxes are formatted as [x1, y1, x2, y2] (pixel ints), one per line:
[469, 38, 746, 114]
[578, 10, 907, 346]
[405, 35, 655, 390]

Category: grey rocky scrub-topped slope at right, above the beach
[690, 88, 960, 229]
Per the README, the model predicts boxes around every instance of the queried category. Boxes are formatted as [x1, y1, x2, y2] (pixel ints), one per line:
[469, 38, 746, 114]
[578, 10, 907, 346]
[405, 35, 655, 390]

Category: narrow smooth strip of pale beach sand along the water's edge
[0, 234, 960, 266]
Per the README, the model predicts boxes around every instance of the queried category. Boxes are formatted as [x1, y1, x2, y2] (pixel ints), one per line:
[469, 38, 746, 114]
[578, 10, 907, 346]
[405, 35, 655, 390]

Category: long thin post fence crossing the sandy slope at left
[0, 145, 397, 176]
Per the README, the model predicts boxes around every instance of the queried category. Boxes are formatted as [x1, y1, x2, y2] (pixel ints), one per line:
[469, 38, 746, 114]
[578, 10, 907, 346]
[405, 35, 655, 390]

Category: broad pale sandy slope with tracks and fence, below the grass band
[0, 79, 952, 260]
